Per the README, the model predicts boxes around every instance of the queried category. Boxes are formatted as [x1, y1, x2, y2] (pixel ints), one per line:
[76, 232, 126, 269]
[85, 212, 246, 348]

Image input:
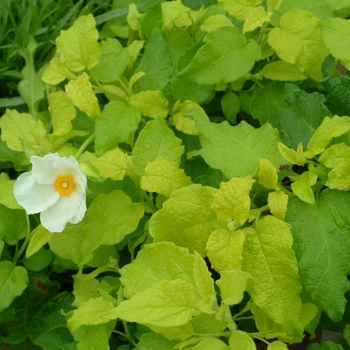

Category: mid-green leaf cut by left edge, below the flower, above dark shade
[0, 261, 29, 311]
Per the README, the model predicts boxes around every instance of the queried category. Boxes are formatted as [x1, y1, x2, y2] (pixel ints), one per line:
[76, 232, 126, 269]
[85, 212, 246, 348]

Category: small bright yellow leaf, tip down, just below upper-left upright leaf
[65, 73, 100, 118]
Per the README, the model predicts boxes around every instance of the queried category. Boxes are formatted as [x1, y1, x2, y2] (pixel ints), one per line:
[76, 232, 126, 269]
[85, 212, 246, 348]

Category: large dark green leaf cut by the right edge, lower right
[286, 189, 350, 321]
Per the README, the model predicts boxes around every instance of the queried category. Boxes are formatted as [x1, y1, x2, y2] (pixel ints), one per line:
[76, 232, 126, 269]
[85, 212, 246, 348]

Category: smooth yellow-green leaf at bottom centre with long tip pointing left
[110, 280, 197, 327]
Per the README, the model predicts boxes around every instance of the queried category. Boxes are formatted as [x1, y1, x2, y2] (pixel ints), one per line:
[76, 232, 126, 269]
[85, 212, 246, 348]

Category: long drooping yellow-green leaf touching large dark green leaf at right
[243, 216, 302, 336]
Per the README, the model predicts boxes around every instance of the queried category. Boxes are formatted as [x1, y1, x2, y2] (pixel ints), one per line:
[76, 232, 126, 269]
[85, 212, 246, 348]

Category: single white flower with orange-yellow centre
[13, 154, 87, 232]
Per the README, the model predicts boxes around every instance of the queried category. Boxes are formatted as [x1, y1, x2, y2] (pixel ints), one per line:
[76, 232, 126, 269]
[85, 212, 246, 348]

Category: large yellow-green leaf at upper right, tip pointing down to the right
[268, 9, 329, 81]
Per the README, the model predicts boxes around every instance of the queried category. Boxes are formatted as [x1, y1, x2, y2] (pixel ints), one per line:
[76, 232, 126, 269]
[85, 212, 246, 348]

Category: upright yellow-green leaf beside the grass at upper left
[56, 14, 101, 72]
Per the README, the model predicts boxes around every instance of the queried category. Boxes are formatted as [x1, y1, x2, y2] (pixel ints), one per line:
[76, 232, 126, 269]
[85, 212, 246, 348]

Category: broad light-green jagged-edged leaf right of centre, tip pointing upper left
[194, 115, 285, 179]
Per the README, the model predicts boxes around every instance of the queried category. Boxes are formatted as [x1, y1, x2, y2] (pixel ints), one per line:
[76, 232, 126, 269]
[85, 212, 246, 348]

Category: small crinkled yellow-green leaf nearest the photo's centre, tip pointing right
[140, 157, 192, 196]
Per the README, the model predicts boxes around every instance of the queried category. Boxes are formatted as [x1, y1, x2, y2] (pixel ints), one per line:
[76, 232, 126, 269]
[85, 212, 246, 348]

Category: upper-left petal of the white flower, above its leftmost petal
[30, 153, 60, 185]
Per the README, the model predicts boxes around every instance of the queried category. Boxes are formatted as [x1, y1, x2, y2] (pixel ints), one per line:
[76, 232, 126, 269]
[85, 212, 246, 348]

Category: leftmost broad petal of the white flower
[13, 172, 60, 214]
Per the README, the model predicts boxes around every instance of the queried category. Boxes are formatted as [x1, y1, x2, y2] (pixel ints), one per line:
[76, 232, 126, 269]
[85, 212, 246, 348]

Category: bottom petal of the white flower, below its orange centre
[40, 191, 85, 232]
